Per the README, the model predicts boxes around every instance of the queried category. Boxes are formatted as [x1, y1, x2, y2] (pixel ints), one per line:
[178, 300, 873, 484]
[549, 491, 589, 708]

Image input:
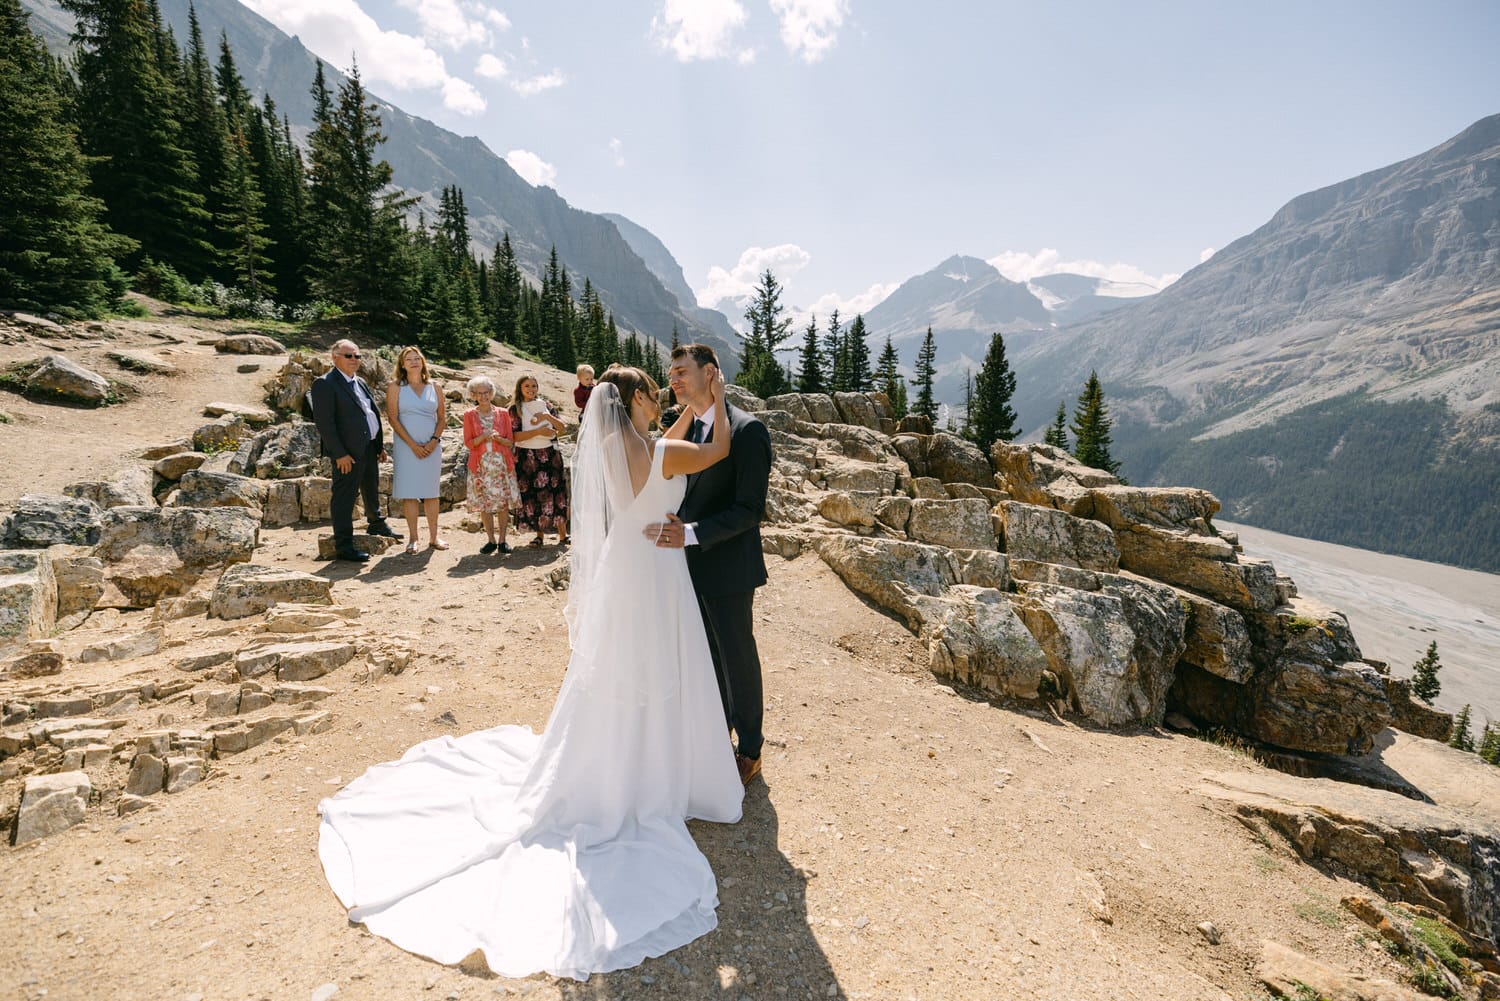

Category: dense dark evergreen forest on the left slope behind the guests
[0, 0, 663, 375]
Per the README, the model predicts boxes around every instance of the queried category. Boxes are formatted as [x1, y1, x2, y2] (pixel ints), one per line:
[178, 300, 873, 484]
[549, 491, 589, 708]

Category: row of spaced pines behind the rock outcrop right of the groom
[735, 269, 1121, 474]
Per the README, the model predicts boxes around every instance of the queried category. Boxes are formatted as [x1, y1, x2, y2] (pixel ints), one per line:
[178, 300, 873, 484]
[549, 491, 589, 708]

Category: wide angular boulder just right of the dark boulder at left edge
[95, 507, 261, 570]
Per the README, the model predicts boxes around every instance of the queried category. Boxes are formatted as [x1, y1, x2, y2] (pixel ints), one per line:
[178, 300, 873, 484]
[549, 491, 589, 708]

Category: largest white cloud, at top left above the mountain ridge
[246, 0, 473, 107]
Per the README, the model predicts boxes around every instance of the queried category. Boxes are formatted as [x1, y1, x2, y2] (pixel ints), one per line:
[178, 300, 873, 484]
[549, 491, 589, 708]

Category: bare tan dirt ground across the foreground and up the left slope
[0, 313, 1428, 1001]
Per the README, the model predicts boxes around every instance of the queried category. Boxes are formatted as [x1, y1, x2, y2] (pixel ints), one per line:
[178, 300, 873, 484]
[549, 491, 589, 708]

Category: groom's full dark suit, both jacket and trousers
[678, 402, 771, 758]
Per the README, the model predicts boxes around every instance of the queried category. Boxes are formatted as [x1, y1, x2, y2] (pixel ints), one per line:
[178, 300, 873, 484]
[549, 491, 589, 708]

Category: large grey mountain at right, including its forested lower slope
[1013, 116, 1500, 570]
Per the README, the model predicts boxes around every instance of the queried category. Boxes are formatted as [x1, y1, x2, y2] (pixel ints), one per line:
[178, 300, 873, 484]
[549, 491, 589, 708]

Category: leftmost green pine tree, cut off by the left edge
[0, 0, 135, 315]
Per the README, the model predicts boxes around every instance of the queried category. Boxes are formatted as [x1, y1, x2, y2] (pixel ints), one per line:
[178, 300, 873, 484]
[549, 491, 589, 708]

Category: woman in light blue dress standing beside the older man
[386, 347, 449, 552]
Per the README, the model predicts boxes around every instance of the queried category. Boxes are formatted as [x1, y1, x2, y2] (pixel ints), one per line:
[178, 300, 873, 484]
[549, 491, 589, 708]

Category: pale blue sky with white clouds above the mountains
[245, 0, 1500, 324]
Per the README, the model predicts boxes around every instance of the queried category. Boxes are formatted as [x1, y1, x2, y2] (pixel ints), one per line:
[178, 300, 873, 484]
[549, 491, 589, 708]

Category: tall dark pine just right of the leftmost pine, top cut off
[63, 0, 215, 278]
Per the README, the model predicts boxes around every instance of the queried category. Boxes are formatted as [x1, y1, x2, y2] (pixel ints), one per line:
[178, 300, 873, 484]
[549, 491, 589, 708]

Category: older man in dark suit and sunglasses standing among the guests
[312, 341, 401, 563]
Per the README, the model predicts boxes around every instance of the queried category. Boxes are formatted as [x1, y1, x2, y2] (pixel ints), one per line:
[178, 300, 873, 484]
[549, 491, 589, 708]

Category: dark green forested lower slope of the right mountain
[1118, 393, 1500, 573]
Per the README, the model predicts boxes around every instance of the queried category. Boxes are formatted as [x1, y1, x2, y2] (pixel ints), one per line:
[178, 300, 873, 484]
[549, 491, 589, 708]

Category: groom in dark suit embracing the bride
[645, 344, 771, 785]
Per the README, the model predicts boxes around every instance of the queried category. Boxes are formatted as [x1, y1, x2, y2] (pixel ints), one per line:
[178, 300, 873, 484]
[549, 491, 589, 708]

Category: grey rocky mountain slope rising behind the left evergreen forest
[24, 0, 738, 371]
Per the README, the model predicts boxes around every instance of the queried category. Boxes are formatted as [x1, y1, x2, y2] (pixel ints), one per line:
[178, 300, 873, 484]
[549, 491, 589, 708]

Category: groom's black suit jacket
[678, 401, 771, 596]
